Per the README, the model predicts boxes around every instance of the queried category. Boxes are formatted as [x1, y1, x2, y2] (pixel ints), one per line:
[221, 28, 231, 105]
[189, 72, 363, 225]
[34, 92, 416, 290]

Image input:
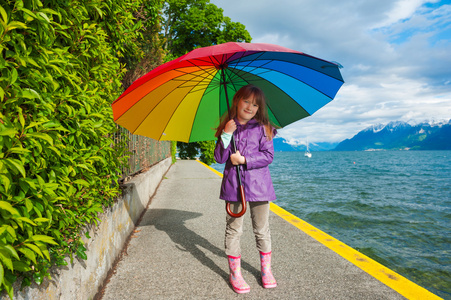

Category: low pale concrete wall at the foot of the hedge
[7, 157, 172, 300]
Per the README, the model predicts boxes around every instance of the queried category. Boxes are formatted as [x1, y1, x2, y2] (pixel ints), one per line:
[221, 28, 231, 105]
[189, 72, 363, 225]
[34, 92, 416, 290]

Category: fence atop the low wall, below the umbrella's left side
[115, 126, 171, 178]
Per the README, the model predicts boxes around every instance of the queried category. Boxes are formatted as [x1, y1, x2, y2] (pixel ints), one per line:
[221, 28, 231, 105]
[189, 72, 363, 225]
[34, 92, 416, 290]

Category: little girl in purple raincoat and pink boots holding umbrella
[215, 85, 277, 293]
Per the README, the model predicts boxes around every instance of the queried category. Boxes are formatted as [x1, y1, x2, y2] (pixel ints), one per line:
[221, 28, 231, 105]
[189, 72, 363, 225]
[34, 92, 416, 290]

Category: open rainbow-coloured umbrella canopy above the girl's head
[112, 42, 343, 142]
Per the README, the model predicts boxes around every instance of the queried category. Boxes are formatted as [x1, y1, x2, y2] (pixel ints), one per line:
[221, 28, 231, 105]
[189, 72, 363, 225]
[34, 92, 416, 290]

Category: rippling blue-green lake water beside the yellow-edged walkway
[212, 151, 451, 299]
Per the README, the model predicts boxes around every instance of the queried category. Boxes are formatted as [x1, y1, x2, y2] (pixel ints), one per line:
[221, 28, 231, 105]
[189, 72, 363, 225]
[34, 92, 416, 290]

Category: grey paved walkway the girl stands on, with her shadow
[102, 161, 405, 300]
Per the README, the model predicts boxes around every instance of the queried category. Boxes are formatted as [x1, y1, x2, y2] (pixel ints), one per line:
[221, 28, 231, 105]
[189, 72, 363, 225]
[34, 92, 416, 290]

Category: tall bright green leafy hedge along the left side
[0, 0, 146, 298]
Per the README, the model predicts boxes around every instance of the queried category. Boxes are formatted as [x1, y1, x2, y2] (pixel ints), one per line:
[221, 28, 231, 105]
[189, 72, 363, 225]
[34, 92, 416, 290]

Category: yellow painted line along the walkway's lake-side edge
[199, 161, 443, 300]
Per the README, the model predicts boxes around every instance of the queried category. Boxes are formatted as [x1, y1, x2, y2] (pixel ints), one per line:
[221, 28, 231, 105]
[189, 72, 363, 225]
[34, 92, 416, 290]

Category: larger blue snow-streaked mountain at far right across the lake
[334, 120, 451, 151]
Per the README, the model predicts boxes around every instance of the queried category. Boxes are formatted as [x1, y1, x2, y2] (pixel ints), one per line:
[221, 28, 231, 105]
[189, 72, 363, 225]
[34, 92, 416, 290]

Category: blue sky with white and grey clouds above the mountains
[210, 0, 451, 144]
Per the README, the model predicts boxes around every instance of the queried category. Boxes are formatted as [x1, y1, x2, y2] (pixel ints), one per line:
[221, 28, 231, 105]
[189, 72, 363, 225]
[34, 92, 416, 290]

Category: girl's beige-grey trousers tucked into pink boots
[224, 201, 271, 256]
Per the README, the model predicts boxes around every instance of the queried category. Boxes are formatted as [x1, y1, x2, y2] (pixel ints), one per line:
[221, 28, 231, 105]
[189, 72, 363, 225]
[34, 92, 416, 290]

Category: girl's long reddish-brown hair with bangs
[215, 84, 275, 140]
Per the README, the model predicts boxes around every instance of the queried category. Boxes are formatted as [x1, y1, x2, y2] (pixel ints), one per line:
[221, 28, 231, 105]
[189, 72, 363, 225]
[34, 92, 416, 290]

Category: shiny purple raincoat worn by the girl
[215, 119, 276, 202]
